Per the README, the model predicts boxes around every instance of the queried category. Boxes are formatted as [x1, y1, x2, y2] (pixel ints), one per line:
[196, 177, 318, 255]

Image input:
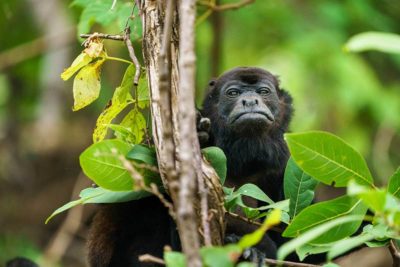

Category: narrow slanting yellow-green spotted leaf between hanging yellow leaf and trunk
[93, 64, 135, 143]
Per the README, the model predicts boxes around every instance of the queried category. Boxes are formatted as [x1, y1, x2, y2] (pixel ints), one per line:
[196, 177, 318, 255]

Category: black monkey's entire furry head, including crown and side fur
[203, 67, 292, 140]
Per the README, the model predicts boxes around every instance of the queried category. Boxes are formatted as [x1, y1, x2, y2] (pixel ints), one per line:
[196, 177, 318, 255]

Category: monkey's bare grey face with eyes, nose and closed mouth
[218, 78, 279, 134]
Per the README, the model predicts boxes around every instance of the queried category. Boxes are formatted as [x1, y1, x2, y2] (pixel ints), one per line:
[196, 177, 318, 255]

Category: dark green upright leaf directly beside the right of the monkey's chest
[283, 158, 318, 218]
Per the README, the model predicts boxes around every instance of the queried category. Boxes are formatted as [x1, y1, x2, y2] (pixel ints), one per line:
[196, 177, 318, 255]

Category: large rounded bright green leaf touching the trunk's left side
[79, 139, 134, 191]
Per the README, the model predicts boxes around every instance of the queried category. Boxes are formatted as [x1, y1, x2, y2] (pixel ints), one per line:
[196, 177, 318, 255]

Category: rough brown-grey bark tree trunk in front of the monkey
[140, 0, 225, 260]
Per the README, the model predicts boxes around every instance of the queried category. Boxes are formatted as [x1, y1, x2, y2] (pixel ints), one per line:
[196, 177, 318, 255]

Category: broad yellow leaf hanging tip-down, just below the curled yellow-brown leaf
[72, 59, 104, 111]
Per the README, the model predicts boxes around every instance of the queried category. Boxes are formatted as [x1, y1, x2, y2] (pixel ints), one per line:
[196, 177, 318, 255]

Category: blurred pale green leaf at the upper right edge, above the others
[344, 32, 400, 54]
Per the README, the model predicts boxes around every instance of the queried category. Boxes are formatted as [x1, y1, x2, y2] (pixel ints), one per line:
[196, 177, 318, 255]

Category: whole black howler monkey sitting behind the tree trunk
[88, 67, 292, 267]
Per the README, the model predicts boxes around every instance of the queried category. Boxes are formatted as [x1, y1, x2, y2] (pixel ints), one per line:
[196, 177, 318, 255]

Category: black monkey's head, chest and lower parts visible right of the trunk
[202, 67, 293, 261]
